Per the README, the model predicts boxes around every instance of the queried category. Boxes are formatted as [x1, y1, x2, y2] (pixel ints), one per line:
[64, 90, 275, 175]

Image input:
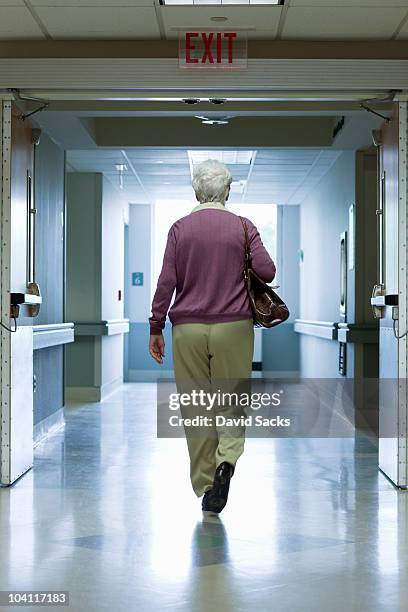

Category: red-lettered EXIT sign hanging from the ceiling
[179, 29, 248, 70]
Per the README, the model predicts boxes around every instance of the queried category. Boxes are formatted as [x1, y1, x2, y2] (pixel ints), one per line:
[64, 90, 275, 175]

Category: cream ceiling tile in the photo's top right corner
[282, 6, 407, 40]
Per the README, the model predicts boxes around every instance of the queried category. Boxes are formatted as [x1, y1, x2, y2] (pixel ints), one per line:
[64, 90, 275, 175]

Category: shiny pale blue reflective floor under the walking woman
[0, 383, 408, 612]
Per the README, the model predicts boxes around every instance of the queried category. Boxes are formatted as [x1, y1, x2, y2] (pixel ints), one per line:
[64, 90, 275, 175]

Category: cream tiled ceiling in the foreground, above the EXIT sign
[0, 0, 408, 40]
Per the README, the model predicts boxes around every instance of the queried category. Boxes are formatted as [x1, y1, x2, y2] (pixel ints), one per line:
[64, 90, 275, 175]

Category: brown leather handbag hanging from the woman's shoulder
[240, 217, 289, 328]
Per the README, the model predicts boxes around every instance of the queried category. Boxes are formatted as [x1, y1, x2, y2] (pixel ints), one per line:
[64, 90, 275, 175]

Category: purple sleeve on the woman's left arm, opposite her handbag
[149, 226, 177, 336]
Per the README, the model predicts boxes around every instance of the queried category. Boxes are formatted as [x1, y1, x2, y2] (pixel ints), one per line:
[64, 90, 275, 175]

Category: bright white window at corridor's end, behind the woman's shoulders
[151, 200, 277, 297]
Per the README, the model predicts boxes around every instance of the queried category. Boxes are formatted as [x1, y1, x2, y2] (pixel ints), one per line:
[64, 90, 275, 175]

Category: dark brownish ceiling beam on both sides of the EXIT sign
[0, 40, 408, 59]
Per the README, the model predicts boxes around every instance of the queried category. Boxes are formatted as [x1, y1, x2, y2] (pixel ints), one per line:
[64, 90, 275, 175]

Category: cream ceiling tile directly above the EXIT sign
[161, 6, 282, 38]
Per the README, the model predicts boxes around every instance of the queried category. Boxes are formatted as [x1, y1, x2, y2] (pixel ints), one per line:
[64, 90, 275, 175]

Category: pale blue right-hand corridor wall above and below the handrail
[299, 151, 355, 378]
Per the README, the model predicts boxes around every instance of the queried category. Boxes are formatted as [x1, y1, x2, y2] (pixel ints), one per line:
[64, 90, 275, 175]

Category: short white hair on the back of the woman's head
[193, 159, 232, 203]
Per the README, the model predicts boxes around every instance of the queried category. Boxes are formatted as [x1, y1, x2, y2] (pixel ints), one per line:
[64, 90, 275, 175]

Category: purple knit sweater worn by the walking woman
[149, 203, 275, 334]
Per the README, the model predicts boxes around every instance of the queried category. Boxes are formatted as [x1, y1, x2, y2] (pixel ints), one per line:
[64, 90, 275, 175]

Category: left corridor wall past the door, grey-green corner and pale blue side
[65, 172, 127, 401]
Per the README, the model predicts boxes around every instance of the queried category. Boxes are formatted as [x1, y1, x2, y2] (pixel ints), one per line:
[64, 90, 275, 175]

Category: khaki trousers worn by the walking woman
[172, 319, 254, 497]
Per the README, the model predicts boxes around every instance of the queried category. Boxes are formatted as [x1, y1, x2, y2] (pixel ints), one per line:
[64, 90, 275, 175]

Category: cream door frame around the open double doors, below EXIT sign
[0, 85, 408, 486]
